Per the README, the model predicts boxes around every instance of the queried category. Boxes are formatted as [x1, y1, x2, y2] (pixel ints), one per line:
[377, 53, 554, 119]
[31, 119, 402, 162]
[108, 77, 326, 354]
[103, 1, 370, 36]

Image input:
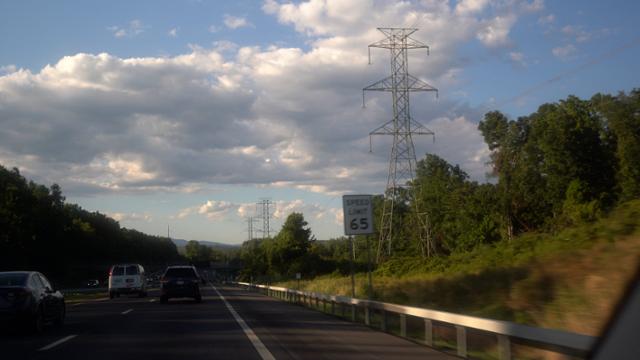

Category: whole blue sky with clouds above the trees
[0, 0, 640, 244]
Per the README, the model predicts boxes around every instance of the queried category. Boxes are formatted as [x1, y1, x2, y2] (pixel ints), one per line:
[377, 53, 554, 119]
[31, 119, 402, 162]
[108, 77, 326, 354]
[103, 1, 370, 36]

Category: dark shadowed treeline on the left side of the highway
[0, 166, 179, 283]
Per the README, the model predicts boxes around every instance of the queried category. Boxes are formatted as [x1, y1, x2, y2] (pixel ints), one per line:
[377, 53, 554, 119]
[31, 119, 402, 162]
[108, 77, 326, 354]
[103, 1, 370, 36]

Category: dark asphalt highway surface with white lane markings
[0, 285, 455, 360]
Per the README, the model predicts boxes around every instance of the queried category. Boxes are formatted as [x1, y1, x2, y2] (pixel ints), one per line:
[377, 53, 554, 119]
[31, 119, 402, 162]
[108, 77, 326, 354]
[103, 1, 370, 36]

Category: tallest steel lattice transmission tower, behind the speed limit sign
[362, 28, 438, 262]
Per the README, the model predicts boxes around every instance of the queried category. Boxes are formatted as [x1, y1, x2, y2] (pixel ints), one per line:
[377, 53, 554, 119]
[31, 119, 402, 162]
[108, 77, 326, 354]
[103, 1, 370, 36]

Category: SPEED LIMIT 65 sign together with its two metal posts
[342, 195, 374, 299]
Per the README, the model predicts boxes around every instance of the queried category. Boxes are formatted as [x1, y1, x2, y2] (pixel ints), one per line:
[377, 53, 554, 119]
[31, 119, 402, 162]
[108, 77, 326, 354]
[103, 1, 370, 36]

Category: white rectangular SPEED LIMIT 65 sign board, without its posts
[342, 195, 374, 235]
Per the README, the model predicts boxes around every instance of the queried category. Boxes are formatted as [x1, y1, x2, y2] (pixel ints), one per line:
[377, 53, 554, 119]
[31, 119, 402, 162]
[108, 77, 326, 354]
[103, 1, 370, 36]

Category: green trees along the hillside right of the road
[241, 89, 640, 278]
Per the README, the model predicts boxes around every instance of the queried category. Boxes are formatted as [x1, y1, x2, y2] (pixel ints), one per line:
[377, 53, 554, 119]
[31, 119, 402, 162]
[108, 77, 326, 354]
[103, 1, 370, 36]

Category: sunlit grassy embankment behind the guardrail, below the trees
[280, 200, 640, 335]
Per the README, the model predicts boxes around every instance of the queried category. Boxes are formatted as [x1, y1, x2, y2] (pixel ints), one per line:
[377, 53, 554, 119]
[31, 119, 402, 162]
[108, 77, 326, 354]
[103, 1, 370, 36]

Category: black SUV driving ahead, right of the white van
[160, 266, 202, 304]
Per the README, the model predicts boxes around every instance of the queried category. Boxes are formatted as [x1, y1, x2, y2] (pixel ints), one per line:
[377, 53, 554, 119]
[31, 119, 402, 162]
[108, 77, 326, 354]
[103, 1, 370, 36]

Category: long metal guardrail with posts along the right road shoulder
[235, 282, 597, 360]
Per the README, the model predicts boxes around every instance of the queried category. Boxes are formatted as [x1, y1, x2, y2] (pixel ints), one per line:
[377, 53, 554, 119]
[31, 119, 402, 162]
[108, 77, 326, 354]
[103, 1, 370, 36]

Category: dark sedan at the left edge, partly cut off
[0, 271, 66, 333]
